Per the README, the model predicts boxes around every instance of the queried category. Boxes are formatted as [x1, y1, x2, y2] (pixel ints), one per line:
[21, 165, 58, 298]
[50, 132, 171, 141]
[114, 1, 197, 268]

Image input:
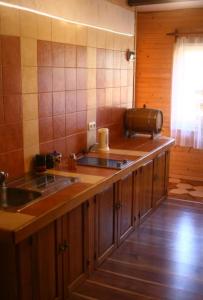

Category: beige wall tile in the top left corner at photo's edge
[0, 7, 20, 36]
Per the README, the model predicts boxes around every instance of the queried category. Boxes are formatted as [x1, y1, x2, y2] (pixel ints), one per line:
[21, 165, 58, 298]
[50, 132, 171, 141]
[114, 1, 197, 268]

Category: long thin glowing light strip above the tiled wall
[0, 1, 134, 37]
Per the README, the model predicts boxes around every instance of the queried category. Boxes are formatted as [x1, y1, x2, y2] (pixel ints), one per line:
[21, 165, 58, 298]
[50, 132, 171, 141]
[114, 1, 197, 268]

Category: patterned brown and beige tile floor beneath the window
[168, 178, 203, 202]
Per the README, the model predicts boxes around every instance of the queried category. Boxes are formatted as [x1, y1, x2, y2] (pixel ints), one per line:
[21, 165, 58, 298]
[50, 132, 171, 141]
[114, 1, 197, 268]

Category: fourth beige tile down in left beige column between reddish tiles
[23, 120, 39, 148]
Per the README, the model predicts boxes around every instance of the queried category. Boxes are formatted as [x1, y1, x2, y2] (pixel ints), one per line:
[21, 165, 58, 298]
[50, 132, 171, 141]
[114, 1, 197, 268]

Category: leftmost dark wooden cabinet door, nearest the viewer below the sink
[17, 220, 62, 300]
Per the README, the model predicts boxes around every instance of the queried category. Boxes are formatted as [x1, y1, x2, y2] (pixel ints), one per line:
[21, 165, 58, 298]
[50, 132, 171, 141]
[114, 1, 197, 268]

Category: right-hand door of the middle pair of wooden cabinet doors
[116, 173, 134, 243]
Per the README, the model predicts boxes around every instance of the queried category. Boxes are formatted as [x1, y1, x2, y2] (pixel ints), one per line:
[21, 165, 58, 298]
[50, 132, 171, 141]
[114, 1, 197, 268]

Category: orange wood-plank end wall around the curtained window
[135, 8, 203, 180]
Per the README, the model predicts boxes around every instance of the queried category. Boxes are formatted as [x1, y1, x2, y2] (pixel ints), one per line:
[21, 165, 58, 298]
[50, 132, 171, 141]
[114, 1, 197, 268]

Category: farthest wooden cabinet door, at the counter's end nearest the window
[153, 152, 168, 207]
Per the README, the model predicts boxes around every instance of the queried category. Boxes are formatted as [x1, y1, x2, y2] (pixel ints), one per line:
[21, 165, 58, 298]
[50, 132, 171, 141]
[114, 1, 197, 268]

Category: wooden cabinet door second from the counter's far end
[140, 160, 153, 220]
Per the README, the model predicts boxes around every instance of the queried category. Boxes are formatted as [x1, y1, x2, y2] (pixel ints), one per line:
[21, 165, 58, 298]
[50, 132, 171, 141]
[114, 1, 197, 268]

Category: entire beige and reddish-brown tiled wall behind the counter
[0, 8, 133, 177]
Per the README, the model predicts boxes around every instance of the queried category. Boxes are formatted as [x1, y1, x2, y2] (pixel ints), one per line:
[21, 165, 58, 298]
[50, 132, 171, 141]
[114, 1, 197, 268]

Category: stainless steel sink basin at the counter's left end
[0, 187, 42, 208]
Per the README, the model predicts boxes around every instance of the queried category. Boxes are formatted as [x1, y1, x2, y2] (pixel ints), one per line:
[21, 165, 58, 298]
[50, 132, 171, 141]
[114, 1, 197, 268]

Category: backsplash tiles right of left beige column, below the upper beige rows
[37, 40, 133, 161]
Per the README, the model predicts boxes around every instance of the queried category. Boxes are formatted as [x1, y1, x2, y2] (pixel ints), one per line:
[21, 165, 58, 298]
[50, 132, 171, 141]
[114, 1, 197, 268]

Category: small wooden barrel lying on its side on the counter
[125, 107, 163, 135]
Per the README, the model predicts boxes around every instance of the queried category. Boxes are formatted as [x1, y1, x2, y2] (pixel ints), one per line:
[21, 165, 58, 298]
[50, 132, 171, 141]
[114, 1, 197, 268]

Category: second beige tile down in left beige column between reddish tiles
[22, 67, 37, 94]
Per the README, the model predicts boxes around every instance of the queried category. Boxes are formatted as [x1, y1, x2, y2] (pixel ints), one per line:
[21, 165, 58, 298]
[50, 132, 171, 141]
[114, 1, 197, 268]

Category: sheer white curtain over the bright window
[171, 37, 203, 148]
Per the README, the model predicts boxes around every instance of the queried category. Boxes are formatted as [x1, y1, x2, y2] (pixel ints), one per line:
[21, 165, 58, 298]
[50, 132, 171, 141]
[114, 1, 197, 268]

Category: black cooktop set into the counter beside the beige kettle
[77, 156, 132, 170]
